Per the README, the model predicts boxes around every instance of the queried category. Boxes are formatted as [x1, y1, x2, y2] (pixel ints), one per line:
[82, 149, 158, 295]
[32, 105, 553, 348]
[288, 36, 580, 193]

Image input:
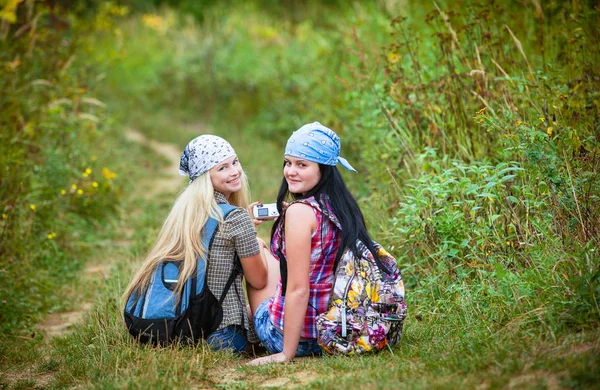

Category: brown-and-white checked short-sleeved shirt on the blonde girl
[207, 191, 260, 343]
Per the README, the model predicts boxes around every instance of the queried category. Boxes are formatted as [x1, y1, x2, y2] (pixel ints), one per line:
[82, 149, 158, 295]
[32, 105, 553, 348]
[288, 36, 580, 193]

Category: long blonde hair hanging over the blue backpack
[123, 171, 250, 304]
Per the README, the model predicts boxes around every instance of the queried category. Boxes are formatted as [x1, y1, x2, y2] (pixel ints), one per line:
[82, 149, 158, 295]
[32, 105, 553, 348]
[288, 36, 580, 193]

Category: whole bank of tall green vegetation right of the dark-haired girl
[338, 2, 600, 350]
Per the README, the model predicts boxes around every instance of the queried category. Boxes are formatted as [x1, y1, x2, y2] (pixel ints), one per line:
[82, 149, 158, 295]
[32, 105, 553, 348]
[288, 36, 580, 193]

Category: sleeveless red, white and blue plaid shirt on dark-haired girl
[269, 195, 342, 339]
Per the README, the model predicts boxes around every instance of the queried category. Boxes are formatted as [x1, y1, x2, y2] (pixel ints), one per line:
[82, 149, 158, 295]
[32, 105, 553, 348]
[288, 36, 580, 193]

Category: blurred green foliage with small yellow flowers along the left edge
[0, 2, 120, 337]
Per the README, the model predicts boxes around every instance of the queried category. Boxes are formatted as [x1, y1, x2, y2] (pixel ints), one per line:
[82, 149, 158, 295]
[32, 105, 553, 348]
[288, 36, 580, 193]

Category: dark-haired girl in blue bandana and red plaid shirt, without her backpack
[248, 122, 378, 365]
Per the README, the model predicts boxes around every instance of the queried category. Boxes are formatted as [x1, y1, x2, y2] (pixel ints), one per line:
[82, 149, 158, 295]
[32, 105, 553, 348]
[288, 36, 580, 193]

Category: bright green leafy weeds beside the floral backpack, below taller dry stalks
[388, 149, 600, 332]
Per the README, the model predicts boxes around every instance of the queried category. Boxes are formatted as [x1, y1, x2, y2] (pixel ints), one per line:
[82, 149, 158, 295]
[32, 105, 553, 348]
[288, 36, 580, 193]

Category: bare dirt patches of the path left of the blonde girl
[38, 129, 185, 340]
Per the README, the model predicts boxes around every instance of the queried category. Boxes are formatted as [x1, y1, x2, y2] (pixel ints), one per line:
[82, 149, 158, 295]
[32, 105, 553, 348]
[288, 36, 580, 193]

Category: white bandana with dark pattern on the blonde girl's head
[179, 134, 236, 183]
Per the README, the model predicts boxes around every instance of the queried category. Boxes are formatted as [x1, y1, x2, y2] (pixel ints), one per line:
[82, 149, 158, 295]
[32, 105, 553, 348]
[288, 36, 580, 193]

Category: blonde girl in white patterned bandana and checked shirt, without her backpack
[124, 135, 267, 352]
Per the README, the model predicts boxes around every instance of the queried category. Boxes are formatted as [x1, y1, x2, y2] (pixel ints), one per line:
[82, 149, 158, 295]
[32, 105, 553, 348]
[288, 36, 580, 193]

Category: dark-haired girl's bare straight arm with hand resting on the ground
[250, 203, 317, 365]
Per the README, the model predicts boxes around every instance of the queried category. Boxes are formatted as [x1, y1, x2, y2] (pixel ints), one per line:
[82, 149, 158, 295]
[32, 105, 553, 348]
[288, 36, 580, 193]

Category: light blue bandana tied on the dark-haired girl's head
[285, 122, 356, 172]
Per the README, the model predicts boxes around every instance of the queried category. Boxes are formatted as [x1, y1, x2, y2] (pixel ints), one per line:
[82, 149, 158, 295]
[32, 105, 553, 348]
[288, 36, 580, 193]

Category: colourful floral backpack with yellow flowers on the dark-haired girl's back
[317, 235, 406, 355]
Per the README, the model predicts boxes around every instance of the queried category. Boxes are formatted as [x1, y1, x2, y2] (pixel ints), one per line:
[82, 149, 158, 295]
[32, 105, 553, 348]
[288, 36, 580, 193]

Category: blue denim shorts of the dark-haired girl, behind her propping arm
[254, 299, 322, 356]
